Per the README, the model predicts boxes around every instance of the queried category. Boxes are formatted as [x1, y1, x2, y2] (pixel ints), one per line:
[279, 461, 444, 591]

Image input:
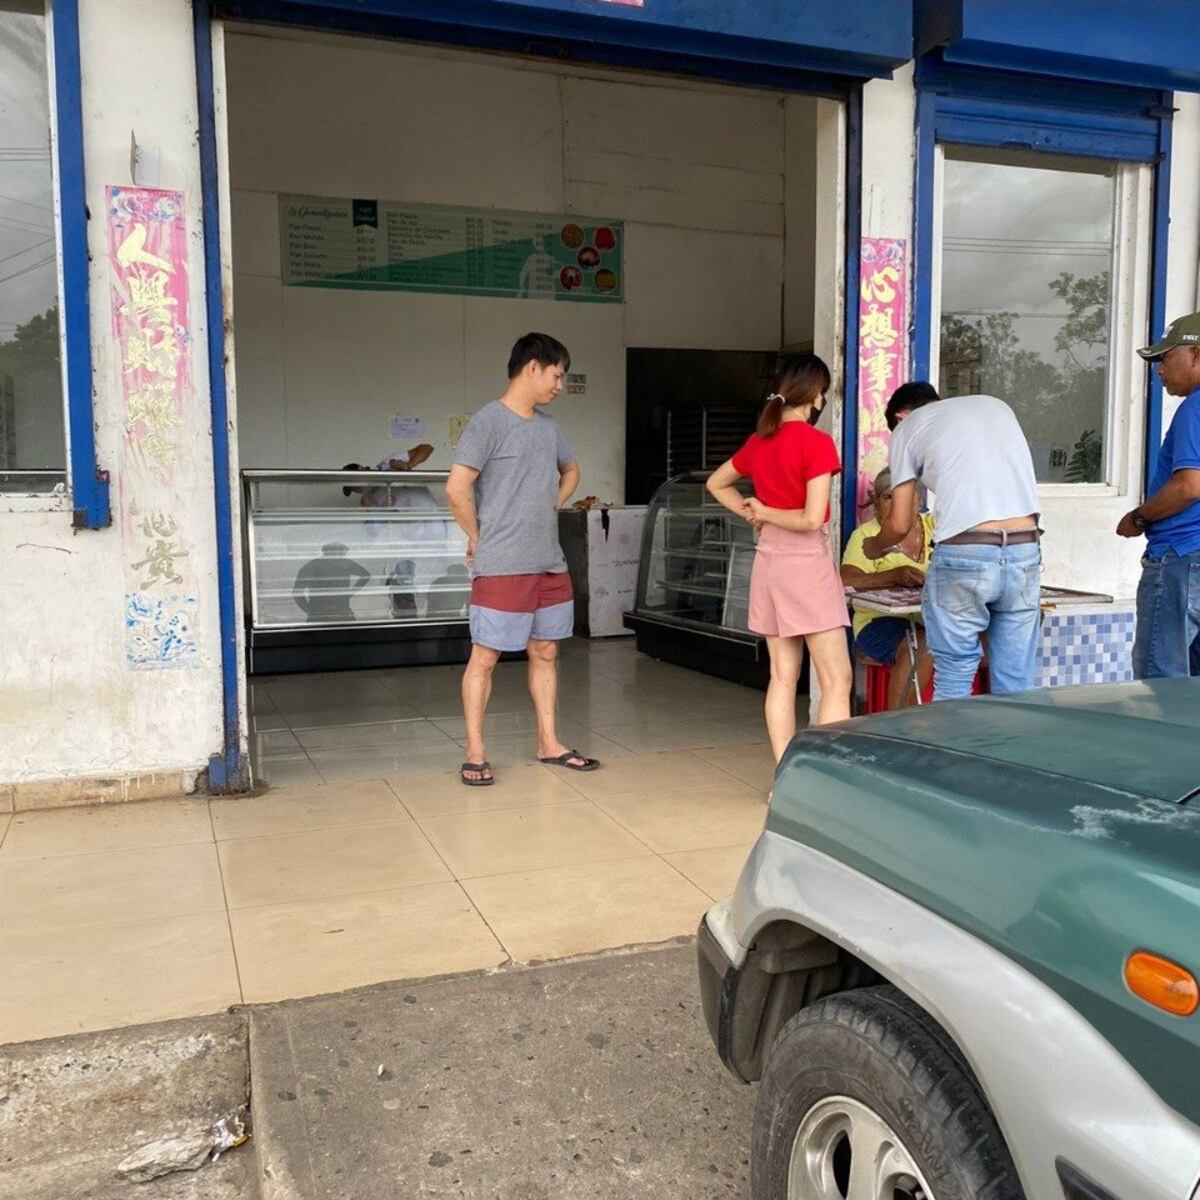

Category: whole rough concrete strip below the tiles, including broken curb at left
[0, 943, 752, 1200]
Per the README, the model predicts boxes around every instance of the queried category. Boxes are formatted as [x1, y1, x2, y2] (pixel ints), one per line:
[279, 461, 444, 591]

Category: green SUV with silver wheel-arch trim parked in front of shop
[698, 679, 1200, 1200]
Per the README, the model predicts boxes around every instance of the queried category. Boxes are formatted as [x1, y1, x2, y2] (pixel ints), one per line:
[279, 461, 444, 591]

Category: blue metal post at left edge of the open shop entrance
[192, 0, 242, 792]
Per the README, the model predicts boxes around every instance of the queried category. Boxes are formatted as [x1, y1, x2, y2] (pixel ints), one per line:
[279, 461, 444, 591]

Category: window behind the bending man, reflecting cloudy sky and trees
[937, 146, 1120, 484]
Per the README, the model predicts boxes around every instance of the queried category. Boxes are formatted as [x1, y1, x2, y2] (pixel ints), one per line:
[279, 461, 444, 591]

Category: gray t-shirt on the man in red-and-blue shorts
[455, 400, 575, 575]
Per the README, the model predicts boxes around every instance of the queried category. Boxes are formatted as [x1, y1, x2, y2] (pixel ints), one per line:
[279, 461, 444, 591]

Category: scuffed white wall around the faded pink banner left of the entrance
[0, 0, 221, 787]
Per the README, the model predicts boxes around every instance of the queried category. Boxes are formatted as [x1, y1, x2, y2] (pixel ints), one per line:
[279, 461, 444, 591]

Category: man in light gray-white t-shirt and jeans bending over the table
[863, 383, 1042, 700]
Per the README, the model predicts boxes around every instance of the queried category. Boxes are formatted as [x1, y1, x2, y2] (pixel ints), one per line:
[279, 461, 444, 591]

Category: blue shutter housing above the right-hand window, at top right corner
[916, 0, 1200, 91]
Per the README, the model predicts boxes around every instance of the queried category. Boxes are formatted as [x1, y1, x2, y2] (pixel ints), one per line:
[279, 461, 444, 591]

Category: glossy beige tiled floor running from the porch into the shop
[0, 642, 772, 1043]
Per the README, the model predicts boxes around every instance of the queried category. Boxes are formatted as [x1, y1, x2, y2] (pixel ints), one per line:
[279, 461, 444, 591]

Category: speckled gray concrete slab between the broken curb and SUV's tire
[251, 944, 752, 1200]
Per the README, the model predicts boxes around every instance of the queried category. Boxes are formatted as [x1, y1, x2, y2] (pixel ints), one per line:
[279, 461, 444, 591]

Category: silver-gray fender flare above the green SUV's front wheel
[707, 832, 1200, 1200]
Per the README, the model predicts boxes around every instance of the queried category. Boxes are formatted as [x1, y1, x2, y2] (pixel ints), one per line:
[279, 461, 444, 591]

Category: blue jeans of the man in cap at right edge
[1133, 550, 1200, 679]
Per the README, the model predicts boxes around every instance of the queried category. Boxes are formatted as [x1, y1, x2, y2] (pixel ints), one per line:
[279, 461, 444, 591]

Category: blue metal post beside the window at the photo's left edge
[52, 0, 113, 529]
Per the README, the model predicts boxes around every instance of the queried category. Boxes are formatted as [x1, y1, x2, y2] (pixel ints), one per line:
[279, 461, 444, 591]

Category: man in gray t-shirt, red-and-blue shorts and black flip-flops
[446, 334, 599, 787]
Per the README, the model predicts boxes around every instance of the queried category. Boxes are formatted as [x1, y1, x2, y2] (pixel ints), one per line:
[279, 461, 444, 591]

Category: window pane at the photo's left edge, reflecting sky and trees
[0, 0, 66, 492]
